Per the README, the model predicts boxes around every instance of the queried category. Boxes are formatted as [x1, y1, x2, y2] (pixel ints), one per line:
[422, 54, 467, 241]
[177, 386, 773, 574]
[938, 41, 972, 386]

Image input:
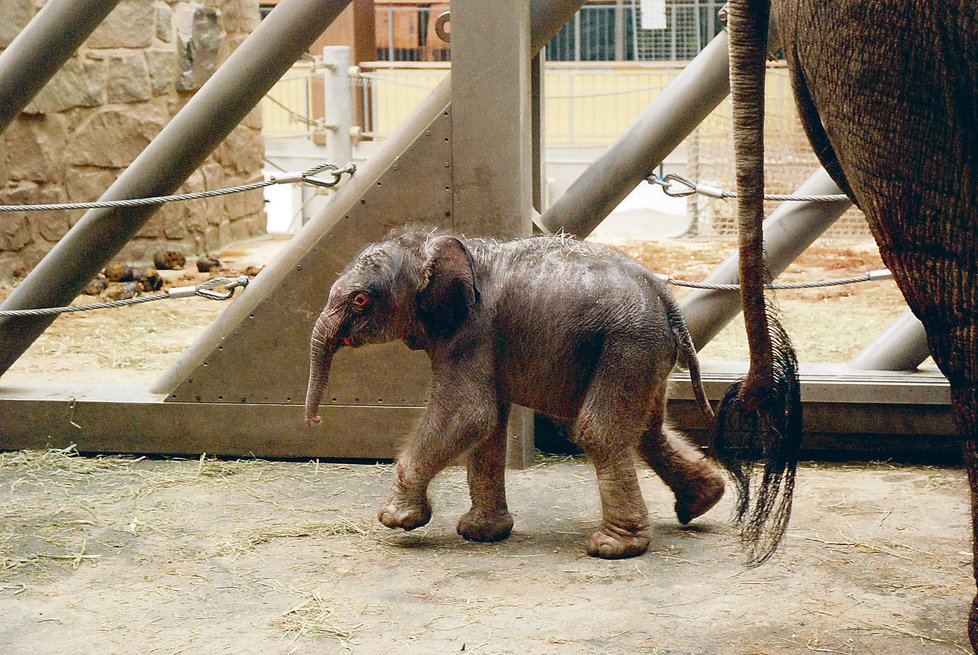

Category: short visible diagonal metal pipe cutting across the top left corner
[0, 0, 119, 133]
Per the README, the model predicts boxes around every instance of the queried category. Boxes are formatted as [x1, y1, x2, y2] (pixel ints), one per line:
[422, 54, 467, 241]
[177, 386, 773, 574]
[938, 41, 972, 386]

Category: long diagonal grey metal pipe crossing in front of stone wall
[0, 0, 350, 375]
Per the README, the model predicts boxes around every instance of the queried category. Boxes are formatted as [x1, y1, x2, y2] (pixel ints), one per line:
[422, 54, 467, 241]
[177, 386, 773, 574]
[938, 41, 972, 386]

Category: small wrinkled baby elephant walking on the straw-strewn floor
[306, 229, 724, 558]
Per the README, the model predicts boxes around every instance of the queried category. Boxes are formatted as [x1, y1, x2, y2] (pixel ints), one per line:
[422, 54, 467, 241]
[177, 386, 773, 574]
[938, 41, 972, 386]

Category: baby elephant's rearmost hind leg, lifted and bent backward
[639, 385, 725, 525]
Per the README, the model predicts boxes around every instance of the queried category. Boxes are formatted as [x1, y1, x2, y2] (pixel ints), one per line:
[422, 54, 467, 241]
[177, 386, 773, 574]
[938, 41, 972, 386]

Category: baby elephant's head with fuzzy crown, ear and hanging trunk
[306, 229, 479, 425]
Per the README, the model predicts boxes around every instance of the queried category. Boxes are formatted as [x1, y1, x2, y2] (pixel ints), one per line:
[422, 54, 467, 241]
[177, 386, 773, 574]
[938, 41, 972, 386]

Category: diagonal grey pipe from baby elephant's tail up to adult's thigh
[681, 168, 852, 350]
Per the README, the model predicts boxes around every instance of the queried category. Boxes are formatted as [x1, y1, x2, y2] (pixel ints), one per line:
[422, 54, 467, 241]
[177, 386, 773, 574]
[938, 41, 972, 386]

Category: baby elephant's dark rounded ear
[418, 236, 479, 336]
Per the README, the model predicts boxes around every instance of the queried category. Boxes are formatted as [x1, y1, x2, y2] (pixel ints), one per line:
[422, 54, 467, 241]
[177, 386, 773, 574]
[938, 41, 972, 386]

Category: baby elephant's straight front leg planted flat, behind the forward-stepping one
[457, 403, 513, 541]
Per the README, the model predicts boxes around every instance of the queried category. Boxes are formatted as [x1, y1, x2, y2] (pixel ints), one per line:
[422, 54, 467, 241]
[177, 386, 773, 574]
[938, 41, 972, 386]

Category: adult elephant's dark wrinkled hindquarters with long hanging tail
[729, 0, 978, 652]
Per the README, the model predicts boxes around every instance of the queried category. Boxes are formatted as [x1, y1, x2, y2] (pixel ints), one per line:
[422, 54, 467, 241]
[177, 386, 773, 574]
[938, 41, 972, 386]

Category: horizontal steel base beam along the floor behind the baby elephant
[0, 364, 960, 459]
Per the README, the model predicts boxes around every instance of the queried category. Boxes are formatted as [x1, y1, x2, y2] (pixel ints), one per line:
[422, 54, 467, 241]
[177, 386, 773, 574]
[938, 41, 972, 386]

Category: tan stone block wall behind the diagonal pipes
[0, 0, 265, 280]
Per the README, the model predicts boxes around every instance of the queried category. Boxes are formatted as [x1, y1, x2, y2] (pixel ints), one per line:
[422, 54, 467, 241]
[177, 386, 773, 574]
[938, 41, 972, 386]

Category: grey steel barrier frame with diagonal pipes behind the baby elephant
[0, 0, 954, 466]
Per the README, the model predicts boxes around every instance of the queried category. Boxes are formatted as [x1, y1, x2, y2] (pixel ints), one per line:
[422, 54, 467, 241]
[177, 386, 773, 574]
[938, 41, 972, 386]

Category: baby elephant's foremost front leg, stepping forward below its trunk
[378, 394, 497, 530]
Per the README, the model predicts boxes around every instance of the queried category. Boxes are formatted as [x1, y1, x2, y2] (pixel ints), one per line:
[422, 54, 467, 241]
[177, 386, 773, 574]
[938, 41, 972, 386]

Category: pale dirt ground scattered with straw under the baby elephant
[0, 233, 974, 655]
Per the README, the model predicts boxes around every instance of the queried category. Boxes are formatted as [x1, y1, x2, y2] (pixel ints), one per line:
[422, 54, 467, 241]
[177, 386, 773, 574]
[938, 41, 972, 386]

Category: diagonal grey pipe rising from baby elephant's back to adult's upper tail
[541, 32, 730, 238]
